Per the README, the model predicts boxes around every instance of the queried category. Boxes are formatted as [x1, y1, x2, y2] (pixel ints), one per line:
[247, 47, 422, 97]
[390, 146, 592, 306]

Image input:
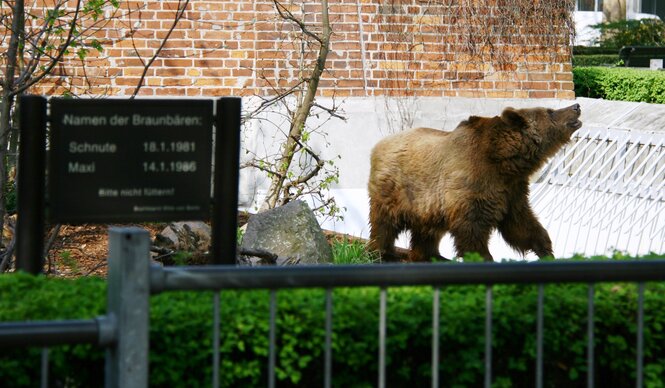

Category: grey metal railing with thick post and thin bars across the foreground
[0, 228, 665, 388]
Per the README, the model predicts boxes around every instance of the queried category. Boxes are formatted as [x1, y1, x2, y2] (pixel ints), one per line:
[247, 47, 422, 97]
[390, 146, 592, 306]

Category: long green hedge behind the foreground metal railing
[0, 256, 665, 387]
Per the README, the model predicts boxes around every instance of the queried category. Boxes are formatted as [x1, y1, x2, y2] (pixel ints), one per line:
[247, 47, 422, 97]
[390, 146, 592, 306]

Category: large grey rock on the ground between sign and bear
[240, 201, 333, 264]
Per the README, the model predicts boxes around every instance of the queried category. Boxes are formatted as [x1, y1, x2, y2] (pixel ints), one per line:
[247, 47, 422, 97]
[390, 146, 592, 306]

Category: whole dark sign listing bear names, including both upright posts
[16, 95, 241, 274]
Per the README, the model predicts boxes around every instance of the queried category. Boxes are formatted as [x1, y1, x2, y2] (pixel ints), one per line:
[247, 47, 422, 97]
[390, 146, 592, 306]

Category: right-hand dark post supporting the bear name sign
[211, 97, 241, 264]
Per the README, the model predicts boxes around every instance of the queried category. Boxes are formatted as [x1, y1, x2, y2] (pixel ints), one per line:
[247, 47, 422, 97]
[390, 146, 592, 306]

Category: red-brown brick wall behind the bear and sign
[24, 0, 574, 98]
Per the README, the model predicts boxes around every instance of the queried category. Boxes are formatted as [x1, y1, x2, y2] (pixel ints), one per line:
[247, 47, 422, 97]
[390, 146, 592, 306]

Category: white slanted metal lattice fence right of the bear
[531, 127, 665, 257]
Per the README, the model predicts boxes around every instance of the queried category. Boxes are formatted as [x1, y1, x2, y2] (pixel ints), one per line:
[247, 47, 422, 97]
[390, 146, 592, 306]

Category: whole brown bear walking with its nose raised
[369, 104, 582, 261]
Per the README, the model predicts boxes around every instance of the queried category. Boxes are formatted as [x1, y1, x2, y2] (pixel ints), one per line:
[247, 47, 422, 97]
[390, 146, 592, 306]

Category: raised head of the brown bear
[490, 104, 582, 173]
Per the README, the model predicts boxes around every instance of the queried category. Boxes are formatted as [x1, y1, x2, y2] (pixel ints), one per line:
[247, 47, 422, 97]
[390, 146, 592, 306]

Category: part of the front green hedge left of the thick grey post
[0, 274, 106, 387]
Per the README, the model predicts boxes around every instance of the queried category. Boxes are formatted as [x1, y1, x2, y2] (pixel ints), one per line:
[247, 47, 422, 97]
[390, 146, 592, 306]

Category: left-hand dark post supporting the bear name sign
[15, 96, 46, 274]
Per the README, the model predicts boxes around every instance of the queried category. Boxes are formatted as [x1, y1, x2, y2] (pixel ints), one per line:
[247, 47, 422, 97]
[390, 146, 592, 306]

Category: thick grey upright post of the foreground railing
[106, 227, 150, 388]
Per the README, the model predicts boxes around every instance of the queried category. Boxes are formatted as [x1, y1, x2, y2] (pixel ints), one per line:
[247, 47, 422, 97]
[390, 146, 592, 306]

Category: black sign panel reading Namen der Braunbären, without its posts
[48, 99, 213, 223]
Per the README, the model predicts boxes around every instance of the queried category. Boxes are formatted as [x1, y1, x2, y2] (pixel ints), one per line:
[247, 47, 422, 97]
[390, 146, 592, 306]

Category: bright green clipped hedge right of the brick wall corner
[573, 67, 665, 104]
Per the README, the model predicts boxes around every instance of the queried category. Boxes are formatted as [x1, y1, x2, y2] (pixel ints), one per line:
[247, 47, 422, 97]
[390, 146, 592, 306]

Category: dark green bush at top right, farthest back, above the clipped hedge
[592, 19, 665, 48]
